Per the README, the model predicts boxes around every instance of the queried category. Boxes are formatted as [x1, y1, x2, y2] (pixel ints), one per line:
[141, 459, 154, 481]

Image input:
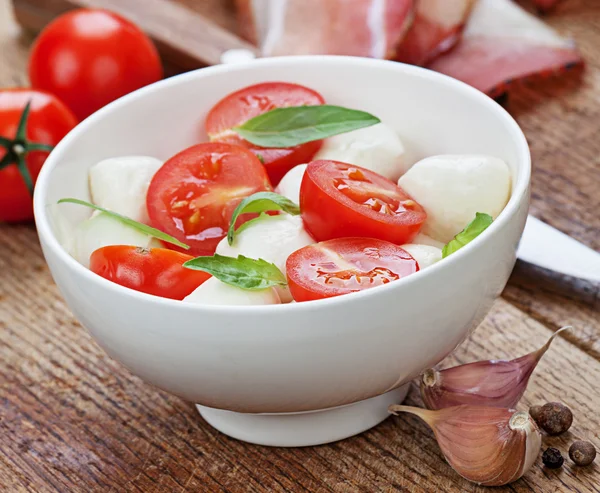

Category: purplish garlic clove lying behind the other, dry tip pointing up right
[421, 327, 571, 409]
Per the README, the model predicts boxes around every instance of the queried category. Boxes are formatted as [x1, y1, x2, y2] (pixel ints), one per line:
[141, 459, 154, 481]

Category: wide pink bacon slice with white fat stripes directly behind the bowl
[237, 0, 415, 58]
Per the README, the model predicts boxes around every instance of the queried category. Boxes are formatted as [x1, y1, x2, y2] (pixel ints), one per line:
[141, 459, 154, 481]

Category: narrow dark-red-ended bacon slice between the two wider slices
[395, 0, 476, 65]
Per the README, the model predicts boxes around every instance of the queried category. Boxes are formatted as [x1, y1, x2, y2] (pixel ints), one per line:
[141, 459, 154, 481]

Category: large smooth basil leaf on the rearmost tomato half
[233, 104, 381, 148]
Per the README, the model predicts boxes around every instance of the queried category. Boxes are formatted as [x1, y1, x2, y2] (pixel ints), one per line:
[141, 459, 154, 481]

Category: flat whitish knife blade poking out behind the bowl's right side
[517, 216, 600, 282]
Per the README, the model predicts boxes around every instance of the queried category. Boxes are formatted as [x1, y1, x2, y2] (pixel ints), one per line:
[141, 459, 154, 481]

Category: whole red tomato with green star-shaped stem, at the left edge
[0, 89, 77, 222]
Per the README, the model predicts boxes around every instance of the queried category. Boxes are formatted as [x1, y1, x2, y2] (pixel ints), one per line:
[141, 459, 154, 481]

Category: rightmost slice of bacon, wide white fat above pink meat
[429, 0, 583, 97]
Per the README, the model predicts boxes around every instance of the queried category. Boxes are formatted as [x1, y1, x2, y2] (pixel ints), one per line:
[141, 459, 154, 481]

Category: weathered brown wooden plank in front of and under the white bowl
[0, 226, 600, 492]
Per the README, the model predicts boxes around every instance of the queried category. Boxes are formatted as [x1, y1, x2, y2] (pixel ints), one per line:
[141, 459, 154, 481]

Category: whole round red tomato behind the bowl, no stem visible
[29, 9, 162, 119]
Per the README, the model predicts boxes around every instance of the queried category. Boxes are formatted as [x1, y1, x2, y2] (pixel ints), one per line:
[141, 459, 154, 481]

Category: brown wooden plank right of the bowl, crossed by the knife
[503, 0, 600, 346]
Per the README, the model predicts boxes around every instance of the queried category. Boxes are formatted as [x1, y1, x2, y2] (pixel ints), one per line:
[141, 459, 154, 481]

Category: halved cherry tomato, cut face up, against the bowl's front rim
[285, 238, 419, 301]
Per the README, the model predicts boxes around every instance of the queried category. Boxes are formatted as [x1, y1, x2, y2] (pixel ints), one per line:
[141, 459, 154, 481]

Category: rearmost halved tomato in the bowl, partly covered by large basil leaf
[206, 82, 325, 186]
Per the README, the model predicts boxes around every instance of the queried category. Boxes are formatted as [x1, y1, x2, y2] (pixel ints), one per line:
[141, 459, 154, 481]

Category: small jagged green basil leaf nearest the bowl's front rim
[183, 253, 287, 291]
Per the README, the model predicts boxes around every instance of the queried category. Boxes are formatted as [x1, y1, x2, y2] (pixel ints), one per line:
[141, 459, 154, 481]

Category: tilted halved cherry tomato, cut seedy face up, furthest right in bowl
[300, 161, 427, 245]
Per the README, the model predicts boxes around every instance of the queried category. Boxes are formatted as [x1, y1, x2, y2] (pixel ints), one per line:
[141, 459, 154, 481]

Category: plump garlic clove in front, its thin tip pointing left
[390, 406, 542, 486]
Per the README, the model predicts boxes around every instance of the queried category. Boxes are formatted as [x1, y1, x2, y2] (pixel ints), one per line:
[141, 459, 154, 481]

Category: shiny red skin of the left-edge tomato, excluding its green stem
[0, 88, 77, 222]
